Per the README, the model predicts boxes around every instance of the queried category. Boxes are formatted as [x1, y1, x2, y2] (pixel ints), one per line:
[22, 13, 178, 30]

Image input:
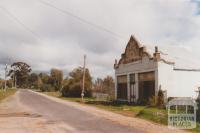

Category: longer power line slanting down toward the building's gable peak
[38, 0, 125, 40]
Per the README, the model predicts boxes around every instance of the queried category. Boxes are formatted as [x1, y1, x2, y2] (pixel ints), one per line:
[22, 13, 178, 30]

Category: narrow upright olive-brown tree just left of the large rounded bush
[51, 69, 63, 91]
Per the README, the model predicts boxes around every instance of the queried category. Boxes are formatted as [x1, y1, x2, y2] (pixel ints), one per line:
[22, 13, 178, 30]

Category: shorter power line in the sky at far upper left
[0, 6, 40, 40]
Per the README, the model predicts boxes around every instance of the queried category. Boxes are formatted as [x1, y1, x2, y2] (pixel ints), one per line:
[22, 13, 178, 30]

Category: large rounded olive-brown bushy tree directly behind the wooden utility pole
[62, 67, 92, 97]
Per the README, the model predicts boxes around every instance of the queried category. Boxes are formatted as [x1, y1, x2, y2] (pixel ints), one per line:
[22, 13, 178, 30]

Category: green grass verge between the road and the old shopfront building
[43, 92, 200, 132]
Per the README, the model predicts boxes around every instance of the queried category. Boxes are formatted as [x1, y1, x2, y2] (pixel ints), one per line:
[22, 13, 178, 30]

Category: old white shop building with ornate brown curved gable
[114, 36, 200, 102]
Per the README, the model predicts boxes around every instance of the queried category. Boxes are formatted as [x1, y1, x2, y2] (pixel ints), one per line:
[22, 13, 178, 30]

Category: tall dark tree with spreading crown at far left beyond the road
[8, 62, 31, 87]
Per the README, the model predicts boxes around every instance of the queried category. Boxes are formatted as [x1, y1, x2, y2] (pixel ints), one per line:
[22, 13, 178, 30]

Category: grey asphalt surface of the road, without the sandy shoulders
[19, 90, 143, 133]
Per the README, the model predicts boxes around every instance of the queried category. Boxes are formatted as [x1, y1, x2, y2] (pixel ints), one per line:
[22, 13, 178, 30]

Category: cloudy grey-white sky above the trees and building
[0, 0, 200, 77]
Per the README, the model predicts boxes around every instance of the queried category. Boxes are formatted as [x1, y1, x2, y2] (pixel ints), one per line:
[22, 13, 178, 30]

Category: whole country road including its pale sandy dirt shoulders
[0, 90, 186, 133]
